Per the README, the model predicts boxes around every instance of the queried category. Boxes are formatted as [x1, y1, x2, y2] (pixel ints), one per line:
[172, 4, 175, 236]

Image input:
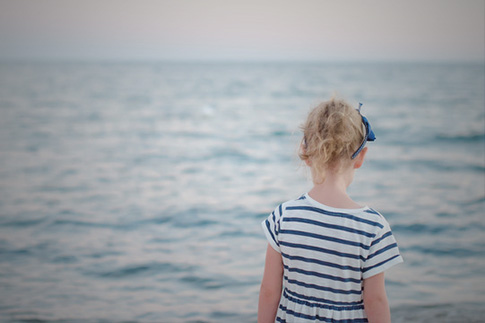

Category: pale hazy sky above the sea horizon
[0, 0, 485, 61]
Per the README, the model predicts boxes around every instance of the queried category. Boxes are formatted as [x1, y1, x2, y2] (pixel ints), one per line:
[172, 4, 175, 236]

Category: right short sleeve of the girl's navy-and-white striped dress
[362, 220, 403, 279]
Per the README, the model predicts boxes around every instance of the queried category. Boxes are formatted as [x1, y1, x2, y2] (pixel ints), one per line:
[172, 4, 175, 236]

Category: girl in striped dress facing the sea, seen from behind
[258, 99, 402, 323]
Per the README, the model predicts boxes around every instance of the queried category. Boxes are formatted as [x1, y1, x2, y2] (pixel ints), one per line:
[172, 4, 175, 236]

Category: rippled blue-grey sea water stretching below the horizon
[0, 62, 485, 322]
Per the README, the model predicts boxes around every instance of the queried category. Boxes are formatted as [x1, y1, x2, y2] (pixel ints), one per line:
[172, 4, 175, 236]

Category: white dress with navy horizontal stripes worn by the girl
[262, 194, 403, 322]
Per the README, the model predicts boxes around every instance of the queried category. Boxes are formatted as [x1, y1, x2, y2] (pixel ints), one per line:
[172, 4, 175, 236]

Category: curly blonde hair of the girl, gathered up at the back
[299, 98, 365, 181]
